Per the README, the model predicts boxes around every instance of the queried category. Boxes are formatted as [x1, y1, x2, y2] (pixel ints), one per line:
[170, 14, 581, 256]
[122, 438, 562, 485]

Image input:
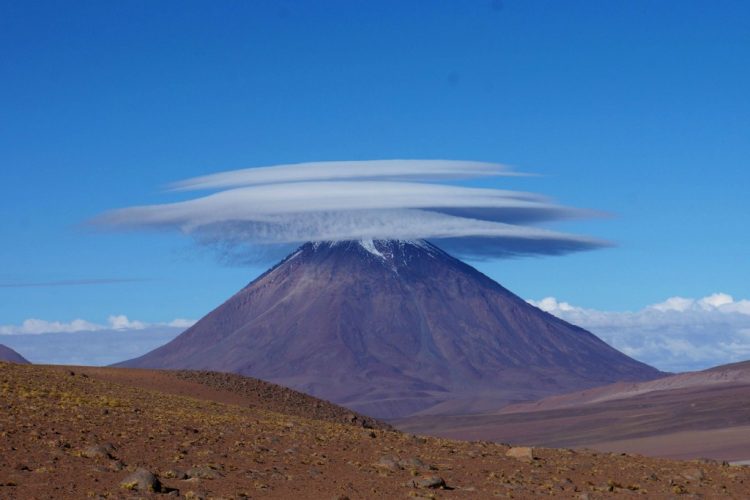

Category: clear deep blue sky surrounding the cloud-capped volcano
[0, 0, 750, 324]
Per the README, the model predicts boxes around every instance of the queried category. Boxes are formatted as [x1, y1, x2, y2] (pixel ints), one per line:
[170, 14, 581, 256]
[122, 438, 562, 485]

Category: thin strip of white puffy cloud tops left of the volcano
[0, 314, 195, 335]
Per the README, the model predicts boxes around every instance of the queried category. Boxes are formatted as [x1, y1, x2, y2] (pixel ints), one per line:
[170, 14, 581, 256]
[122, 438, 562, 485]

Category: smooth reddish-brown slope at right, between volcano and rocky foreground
[396, 362, 750, 461]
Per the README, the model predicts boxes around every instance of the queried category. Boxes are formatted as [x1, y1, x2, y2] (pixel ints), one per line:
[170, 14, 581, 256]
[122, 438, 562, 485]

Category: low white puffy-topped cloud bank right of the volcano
[528, 293, 750, 371]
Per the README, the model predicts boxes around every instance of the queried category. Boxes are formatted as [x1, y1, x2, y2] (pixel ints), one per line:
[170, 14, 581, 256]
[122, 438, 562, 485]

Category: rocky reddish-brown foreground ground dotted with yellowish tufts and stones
[0, 363, 750, 499]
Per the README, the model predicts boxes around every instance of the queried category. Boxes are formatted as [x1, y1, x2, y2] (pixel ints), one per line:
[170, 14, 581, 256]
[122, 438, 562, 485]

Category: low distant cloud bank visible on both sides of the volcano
[0, 293, 750, 372]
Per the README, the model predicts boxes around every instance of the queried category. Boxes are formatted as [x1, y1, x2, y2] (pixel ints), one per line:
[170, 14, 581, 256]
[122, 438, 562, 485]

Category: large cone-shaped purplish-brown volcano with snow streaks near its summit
[119, 240, 663, 418]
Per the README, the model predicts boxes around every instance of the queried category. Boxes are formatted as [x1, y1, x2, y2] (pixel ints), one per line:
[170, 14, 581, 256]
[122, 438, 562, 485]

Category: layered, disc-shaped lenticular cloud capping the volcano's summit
[94, 160, 607, 258]
